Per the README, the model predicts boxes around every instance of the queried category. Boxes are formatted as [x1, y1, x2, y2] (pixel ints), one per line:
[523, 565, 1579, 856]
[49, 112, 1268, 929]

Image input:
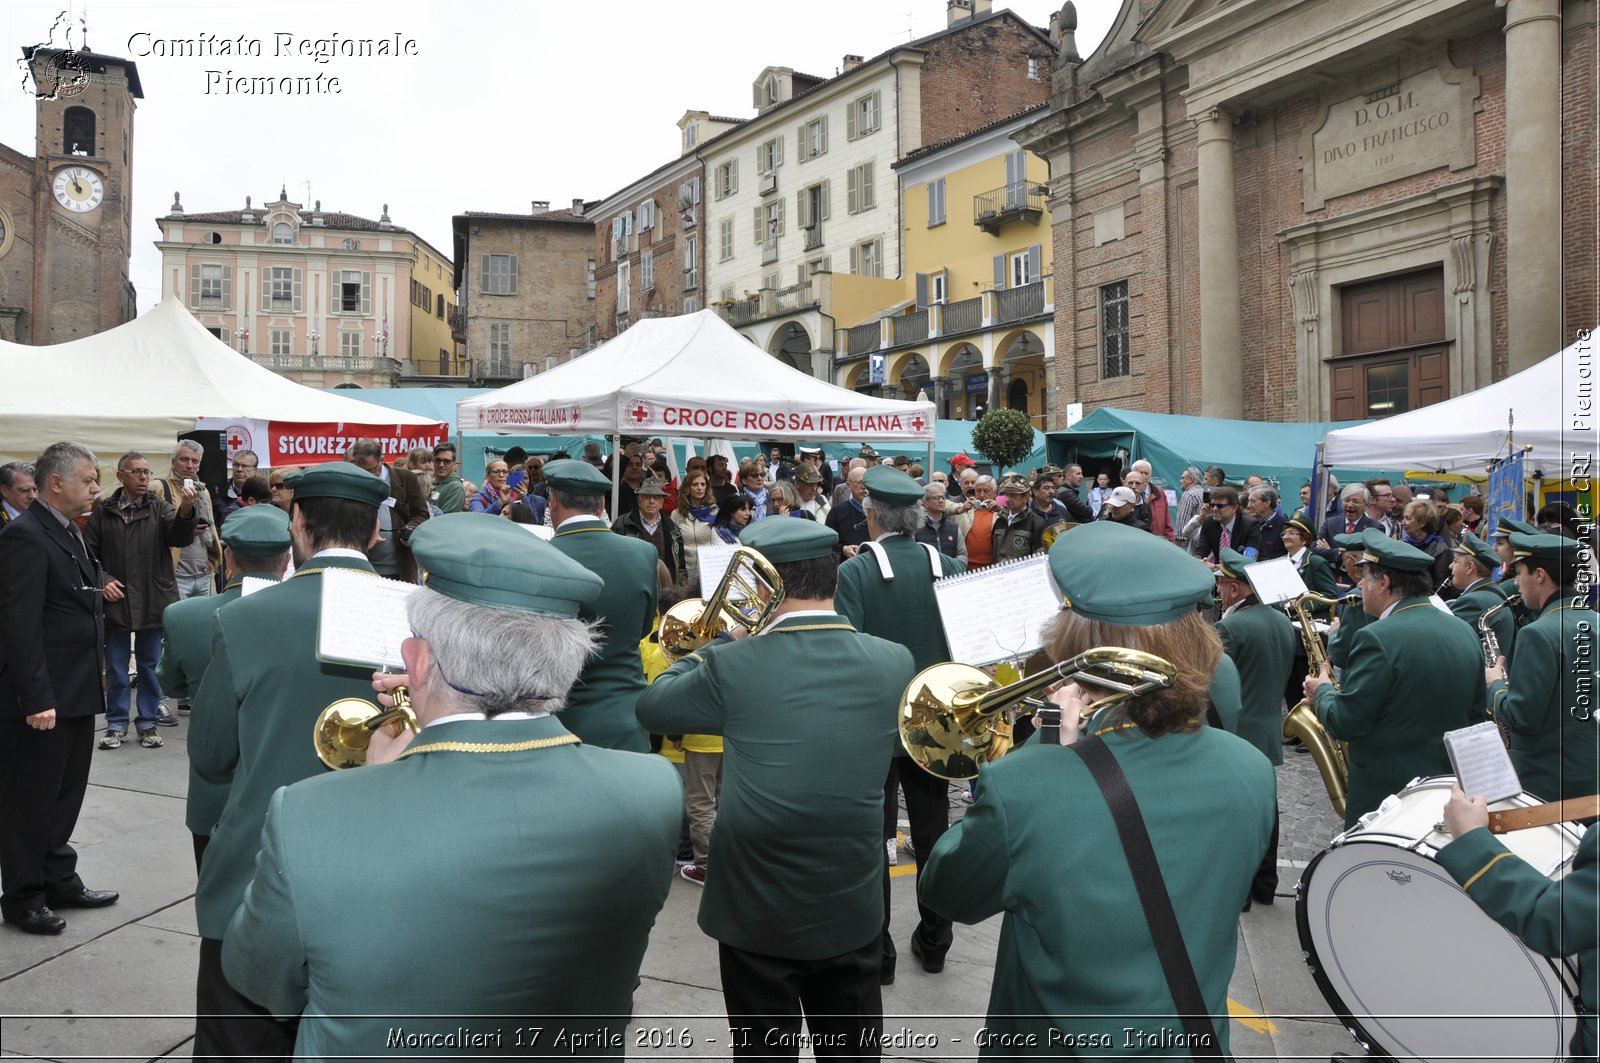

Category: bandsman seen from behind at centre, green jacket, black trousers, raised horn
[638, 520, 915, 1060]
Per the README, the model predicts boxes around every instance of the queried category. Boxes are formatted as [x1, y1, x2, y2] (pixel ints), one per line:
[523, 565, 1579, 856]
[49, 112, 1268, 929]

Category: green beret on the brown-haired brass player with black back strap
[1049, 520, 1216, 628]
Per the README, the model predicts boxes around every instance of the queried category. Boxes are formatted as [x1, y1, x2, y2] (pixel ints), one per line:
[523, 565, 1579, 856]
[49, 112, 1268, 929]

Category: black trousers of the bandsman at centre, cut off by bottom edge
[717, 938, 883, 1060]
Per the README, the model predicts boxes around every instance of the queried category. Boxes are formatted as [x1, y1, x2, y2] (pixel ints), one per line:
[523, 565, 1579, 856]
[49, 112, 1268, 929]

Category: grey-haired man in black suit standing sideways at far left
[0, 443, 117, 933]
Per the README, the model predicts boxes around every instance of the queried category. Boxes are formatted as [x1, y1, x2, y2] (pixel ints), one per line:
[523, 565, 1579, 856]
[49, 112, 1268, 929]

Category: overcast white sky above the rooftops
[0, 0, 1120, 314]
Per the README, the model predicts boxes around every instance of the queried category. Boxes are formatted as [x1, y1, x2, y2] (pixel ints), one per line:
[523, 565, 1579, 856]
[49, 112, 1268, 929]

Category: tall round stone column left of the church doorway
[1179, 107, 1241, 419]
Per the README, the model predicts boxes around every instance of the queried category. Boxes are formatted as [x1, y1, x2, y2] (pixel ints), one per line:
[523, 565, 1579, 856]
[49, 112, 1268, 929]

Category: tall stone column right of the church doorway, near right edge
[1499, 0, 1565, 373]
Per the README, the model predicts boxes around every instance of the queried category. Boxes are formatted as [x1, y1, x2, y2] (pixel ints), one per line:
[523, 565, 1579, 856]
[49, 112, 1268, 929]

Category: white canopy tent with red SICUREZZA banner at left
[0, 296, 448, 466]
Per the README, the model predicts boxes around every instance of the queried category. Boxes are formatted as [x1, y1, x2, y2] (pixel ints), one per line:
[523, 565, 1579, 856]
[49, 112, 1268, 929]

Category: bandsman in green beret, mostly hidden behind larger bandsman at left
[155, 506, 290, 871]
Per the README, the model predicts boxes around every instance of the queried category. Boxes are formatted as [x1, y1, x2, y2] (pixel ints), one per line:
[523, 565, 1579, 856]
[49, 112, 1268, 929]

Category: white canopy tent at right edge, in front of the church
[1322, 338, 1595, 477]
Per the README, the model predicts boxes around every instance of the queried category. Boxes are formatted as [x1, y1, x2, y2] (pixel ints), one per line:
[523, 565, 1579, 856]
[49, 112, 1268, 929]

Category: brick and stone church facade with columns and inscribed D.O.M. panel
[1016, 0, 1600, 424]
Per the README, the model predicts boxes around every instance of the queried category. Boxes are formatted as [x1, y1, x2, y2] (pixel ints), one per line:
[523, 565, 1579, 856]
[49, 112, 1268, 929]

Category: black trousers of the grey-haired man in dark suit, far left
[0, 716, 96, 919]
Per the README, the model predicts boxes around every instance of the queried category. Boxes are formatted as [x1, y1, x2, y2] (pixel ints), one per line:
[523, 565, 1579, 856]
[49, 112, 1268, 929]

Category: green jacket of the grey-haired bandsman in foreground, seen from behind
[222, 717, 683, 1058]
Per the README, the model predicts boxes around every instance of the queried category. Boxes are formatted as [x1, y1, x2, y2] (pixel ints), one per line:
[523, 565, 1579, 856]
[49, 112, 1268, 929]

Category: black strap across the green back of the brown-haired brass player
[1069, 735, 1222, 1060]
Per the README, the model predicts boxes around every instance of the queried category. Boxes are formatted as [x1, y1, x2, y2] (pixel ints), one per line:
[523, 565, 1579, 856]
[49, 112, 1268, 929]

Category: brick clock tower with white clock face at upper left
[0, 45, 144, 344]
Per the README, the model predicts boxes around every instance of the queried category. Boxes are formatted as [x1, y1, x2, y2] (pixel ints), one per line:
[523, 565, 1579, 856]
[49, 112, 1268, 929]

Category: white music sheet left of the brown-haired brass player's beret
[933, 554, 1061, 666]
